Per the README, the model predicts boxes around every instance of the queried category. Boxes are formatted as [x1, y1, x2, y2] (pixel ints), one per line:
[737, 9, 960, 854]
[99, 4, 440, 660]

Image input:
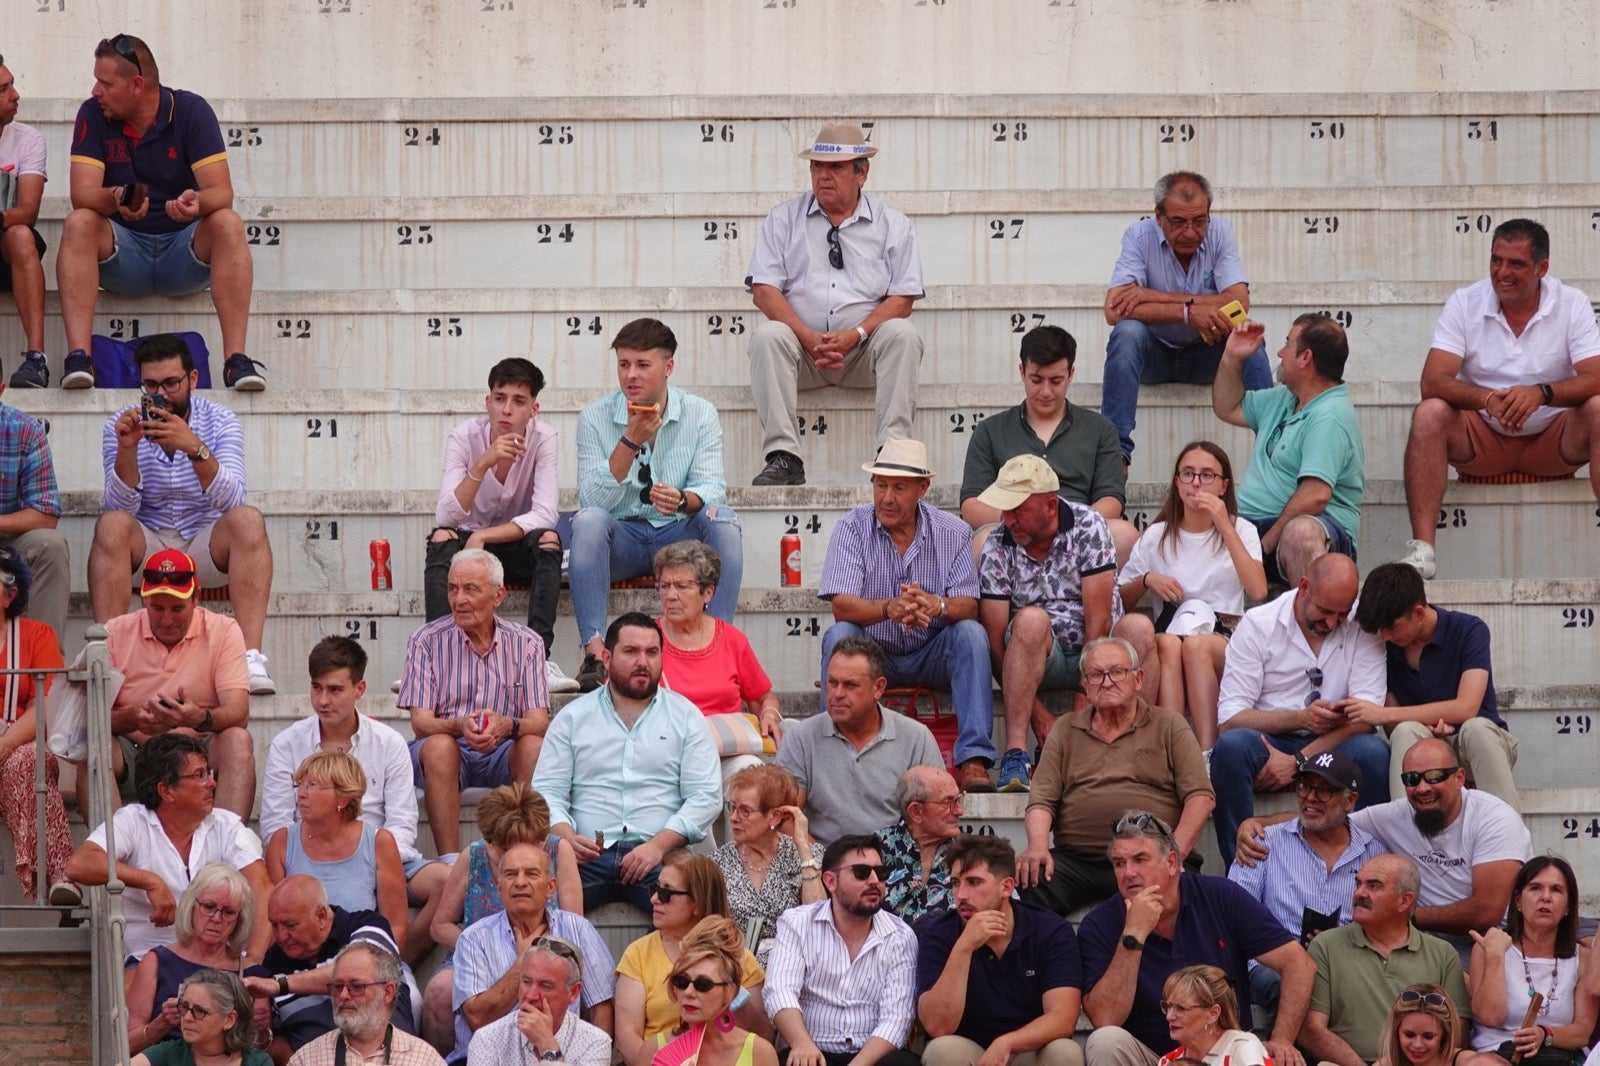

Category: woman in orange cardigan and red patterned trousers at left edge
[0, 547, 70, 906]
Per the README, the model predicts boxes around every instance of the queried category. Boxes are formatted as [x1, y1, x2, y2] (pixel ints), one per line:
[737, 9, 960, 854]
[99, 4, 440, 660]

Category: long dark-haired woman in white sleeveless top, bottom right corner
[1467, 855, 1597, 1066]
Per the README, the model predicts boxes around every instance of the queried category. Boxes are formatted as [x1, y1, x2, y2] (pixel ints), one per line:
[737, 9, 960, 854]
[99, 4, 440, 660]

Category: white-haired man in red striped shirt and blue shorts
[395, 547, 550, 861]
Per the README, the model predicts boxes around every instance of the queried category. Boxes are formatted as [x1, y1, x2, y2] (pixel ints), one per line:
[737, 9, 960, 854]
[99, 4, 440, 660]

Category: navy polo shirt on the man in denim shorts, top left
[72, 86, 227, 234]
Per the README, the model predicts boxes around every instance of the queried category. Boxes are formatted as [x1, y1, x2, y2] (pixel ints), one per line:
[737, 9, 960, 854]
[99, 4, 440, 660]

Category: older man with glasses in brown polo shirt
[1016, 637, 1216, 916]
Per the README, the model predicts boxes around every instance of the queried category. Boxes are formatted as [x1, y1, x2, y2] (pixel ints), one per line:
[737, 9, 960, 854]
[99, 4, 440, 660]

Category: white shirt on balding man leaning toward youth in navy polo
[1216, 589, 1389, 725]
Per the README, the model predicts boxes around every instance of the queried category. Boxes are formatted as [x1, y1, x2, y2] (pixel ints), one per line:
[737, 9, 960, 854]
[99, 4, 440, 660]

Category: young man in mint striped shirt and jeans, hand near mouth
[568, 319, 744, 691]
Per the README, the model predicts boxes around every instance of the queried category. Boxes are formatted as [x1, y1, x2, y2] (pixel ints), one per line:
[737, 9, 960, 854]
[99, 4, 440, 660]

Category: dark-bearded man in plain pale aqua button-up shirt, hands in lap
[533, 611, 722, 914]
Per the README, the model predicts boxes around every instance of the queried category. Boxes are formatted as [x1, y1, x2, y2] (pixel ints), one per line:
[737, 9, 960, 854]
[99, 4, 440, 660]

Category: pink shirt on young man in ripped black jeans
[434, 418, 562, 533]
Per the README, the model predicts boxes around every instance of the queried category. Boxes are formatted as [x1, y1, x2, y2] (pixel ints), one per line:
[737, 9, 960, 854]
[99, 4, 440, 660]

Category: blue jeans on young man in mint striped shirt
[566, 504, 744, 645]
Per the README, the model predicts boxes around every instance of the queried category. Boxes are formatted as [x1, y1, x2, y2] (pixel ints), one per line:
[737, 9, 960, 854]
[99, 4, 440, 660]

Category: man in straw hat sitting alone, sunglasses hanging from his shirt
[744, 123, 925, 485]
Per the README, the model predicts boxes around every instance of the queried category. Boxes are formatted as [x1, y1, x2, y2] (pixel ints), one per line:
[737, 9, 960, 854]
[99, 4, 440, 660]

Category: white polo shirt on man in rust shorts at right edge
[1432, 275, 1600, 437]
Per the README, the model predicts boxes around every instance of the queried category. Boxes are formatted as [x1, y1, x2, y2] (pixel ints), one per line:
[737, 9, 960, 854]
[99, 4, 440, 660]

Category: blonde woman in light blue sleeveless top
[267, 751, 411, 943]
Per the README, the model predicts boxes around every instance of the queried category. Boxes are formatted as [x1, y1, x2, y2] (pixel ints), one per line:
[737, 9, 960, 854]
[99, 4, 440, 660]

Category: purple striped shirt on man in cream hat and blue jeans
[816, 501, 978, 655]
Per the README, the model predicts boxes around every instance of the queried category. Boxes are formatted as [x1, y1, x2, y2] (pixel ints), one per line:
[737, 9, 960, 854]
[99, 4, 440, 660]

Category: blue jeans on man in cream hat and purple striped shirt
[822, 619, 995, 765]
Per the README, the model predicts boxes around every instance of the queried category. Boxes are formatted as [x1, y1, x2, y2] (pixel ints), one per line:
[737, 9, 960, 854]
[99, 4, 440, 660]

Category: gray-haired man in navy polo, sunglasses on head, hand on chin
[1078, 810, 1317, 1066]
